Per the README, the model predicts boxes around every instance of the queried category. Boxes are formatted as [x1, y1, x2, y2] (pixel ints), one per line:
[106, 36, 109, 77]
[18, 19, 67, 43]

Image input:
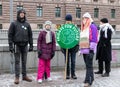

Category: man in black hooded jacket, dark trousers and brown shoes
[8, 9, 33, 84]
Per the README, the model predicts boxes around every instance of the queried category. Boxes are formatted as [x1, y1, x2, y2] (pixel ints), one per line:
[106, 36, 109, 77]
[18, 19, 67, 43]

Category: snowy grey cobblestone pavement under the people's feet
[0, 68, 120, 87]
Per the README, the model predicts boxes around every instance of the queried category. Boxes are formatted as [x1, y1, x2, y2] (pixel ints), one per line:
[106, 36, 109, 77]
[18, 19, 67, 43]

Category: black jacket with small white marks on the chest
[8, 20, 33, 45]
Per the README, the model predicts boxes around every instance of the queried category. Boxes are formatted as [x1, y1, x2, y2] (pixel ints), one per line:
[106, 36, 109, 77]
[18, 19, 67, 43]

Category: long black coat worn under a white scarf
[96, 29, 112, 61]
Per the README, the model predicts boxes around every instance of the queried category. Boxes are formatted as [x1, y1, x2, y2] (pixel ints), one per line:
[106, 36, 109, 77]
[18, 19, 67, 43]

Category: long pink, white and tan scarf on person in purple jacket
[80, 18, 91, 48]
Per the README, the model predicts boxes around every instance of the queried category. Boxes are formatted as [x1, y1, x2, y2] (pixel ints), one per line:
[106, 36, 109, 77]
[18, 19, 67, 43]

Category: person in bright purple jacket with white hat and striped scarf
[80, 12, 98, 87]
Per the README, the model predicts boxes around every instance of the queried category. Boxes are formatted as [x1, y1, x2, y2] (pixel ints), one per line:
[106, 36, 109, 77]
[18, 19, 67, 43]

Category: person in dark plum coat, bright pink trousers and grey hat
[37, 21, 56, 83]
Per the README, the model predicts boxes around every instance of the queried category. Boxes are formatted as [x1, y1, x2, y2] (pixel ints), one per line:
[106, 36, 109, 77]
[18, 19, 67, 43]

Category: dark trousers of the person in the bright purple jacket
[83, 52, 94, 85]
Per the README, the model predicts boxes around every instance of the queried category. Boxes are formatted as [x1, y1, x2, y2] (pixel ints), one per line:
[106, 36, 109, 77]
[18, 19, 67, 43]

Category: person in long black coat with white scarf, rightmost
[95, 18, 114, 77]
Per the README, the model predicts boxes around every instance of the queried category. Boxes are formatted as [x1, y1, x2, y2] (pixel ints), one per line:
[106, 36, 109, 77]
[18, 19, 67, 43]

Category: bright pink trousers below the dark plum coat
[37, 58, 50, 80]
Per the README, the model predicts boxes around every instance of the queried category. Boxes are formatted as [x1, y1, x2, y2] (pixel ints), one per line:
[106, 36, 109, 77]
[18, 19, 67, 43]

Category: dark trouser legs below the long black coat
[98, 59, 110, 74]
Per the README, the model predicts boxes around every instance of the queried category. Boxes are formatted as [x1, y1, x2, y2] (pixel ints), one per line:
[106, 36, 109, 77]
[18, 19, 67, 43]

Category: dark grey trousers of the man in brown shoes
[14, 45, 28, 77]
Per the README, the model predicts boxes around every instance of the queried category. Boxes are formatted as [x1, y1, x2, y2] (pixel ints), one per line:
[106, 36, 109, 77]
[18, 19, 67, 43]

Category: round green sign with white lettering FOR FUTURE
[56, 24, 80, 49]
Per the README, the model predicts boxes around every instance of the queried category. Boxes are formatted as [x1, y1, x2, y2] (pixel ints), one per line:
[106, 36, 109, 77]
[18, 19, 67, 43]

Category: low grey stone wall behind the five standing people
[0, 30, 120, 71]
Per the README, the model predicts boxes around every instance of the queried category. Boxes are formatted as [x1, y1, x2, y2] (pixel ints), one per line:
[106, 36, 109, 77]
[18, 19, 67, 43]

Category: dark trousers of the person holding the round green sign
[64, 51, 76, 76]
